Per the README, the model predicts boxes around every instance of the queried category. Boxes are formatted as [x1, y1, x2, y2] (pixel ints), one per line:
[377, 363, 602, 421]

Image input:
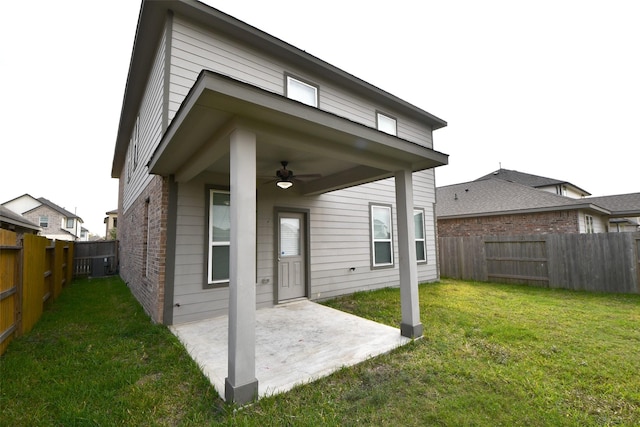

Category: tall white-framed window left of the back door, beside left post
[208, 190, 231, 285]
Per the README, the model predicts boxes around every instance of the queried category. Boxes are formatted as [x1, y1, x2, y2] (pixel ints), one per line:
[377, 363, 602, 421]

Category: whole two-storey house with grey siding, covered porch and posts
[112, 0, 447, 402]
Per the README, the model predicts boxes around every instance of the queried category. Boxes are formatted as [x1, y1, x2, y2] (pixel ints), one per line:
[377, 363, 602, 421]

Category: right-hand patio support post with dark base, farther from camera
[395, 170, 422, 338]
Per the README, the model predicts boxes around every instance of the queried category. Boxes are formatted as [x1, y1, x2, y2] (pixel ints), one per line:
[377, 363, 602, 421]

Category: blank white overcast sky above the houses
[0, 0, 640, 235]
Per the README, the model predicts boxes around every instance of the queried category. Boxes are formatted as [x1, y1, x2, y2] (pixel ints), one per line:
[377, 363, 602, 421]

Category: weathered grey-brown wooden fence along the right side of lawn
[438, 233, 640, 293]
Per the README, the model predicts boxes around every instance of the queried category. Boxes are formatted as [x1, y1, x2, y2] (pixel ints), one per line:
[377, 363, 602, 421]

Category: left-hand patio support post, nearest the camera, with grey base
[225, 129, 258, 405]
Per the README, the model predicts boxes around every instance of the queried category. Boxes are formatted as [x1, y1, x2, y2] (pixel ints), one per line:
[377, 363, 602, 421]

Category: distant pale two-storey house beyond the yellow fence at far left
[2, 194, 83, 240]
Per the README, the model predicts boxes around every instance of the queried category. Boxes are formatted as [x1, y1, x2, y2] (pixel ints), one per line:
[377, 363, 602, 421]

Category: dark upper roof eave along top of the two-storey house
[111, 0, 447, 178]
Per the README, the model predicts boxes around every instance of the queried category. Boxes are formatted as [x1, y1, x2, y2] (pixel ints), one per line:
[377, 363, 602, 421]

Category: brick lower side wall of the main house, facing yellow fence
[118, 176, 169, 323]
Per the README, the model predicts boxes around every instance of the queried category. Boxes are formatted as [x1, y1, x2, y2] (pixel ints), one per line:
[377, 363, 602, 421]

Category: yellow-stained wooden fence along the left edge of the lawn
[0, 229, 74, 355]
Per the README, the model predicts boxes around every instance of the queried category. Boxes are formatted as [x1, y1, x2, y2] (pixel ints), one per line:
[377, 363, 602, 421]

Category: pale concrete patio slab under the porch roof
[171, 300, 411, 398]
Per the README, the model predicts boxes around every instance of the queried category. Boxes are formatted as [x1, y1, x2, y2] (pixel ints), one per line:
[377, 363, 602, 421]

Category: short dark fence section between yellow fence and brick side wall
[73, 240, 118, 277]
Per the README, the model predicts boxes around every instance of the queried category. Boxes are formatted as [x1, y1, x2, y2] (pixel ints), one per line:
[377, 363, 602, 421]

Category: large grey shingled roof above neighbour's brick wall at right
[436, 179, 609, 219]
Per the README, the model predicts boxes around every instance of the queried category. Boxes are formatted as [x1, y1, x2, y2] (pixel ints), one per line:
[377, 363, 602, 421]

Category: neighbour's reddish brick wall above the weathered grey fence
[438, 211, 580, 237]
